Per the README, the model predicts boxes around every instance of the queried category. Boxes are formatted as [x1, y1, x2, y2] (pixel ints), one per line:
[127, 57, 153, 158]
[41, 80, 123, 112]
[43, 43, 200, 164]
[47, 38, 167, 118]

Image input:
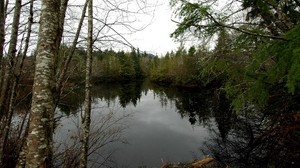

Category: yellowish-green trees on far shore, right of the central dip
[150, 46, 201, 86]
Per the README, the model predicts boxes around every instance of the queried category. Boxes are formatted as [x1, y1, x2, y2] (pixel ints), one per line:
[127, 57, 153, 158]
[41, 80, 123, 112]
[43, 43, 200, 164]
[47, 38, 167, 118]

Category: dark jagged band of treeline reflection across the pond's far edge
[58, 81, 223, 125]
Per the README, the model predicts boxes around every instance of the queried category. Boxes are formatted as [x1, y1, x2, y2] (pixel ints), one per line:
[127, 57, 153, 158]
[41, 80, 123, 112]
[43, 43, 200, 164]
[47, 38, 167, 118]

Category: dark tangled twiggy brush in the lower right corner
[204, 109, 300, 167]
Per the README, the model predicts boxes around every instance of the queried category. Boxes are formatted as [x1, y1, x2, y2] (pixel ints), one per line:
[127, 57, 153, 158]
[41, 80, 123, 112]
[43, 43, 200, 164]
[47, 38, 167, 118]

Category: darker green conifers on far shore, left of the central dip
[60, 46, 152, 82]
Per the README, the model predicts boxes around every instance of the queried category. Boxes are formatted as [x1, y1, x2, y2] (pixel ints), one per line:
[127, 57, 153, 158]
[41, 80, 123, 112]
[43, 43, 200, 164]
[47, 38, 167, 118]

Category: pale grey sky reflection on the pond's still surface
[55, 91, 208, 168]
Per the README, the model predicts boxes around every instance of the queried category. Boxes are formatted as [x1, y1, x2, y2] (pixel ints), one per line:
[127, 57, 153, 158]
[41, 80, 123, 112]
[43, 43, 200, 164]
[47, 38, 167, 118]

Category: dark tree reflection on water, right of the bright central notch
[153, 86, 230, 126]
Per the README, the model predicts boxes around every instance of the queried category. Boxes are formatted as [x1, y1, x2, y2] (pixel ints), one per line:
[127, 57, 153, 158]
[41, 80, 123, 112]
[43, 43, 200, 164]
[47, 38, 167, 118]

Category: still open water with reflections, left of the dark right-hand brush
[55, 80, 218, 167]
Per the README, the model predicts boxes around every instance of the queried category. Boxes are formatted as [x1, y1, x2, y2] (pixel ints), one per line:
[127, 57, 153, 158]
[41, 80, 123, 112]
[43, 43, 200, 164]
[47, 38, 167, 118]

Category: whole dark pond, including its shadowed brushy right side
[54, 82, 299, 168]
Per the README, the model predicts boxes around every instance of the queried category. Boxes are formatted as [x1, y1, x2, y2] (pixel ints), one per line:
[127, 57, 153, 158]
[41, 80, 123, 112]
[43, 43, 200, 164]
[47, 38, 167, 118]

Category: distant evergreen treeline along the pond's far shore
[25, 45, 207, 86]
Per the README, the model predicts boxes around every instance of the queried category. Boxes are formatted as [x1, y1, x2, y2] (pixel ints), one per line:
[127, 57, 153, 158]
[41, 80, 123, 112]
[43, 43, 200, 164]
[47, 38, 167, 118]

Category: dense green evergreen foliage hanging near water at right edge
[227, 24, 300, 109]
